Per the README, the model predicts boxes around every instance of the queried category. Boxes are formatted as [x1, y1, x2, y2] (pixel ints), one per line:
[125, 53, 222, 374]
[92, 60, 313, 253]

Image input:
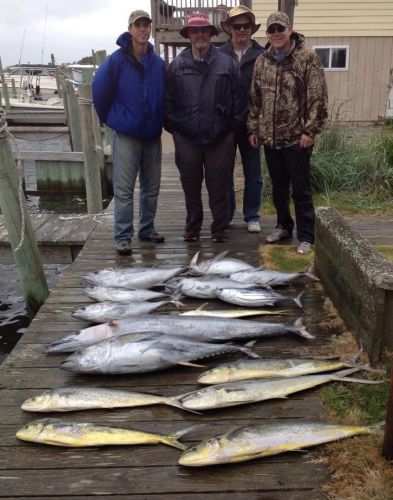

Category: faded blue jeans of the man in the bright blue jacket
[113, 132, 161, 243]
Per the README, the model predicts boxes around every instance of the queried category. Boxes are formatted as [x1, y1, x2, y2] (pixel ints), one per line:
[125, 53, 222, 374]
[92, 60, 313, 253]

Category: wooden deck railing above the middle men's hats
[151, 0, 245, 31]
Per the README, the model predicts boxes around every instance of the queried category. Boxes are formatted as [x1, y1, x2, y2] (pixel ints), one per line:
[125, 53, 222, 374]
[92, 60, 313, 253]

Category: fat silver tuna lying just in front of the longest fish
[60, 332, 258, 374]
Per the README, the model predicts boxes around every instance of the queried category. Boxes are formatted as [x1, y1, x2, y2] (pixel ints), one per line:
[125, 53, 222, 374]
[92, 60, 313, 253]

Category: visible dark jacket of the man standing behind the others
[218, 40, 265, 134]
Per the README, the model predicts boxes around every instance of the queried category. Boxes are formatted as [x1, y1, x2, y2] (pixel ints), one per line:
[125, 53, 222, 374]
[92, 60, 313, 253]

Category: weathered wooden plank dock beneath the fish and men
[0, 154, 393, 500]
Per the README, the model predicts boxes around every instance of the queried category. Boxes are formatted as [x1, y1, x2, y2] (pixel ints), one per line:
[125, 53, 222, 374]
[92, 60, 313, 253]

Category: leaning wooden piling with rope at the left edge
[0, 109, 49, 316]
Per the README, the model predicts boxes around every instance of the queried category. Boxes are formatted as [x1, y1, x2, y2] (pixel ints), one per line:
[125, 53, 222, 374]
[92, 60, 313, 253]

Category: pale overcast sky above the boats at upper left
[0, 0, 150, 67]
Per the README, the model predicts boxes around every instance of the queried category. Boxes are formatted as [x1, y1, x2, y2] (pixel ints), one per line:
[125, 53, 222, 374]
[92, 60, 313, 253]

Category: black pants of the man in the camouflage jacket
[265, 145, 315, 243]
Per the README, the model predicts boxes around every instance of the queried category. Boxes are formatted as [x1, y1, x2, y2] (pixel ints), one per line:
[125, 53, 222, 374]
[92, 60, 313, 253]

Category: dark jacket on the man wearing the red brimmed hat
[164, 46, 244, 146]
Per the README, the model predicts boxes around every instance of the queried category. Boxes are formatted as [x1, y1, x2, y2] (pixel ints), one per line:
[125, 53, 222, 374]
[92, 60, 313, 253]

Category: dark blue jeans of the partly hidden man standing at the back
[229, 135, 263, 222]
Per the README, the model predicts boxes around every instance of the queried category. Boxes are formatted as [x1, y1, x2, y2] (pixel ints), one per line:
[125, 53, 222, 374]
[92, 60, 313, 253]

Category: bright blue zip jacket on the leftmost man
[93, 32, 165, 140]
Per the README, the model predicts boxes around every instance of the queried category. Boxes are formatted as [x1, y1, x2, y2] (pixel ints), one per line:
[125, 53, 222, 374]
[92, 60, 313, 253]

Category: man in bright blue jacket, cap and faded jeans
[93, 10, 165, 255]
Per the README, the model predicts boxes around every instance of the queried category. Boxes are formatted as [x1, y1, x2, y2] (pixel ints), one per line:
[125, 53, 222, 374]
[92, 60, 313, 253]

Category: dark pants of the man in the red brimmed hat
[173, 132, 235, 235]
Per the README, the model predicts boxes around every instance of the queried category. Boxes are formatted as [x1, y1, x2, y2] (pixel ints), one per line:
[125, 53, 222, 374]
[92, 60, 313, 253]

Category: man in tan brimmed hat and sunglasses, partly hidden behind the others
[218, 5, 264, 233]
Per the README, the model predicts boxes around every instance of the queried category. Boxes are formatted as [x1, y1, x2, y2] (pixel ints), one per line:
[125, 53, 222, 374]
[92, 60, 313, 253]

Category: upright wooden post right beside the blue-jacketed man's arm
[79, 83, 102, 214]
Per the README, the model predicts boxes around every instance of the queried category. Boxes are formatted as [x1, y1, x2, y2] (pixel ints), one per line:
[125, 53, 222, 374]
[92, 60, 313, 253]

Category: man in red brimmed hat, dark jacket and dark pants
[165, 12, 244, 243]
